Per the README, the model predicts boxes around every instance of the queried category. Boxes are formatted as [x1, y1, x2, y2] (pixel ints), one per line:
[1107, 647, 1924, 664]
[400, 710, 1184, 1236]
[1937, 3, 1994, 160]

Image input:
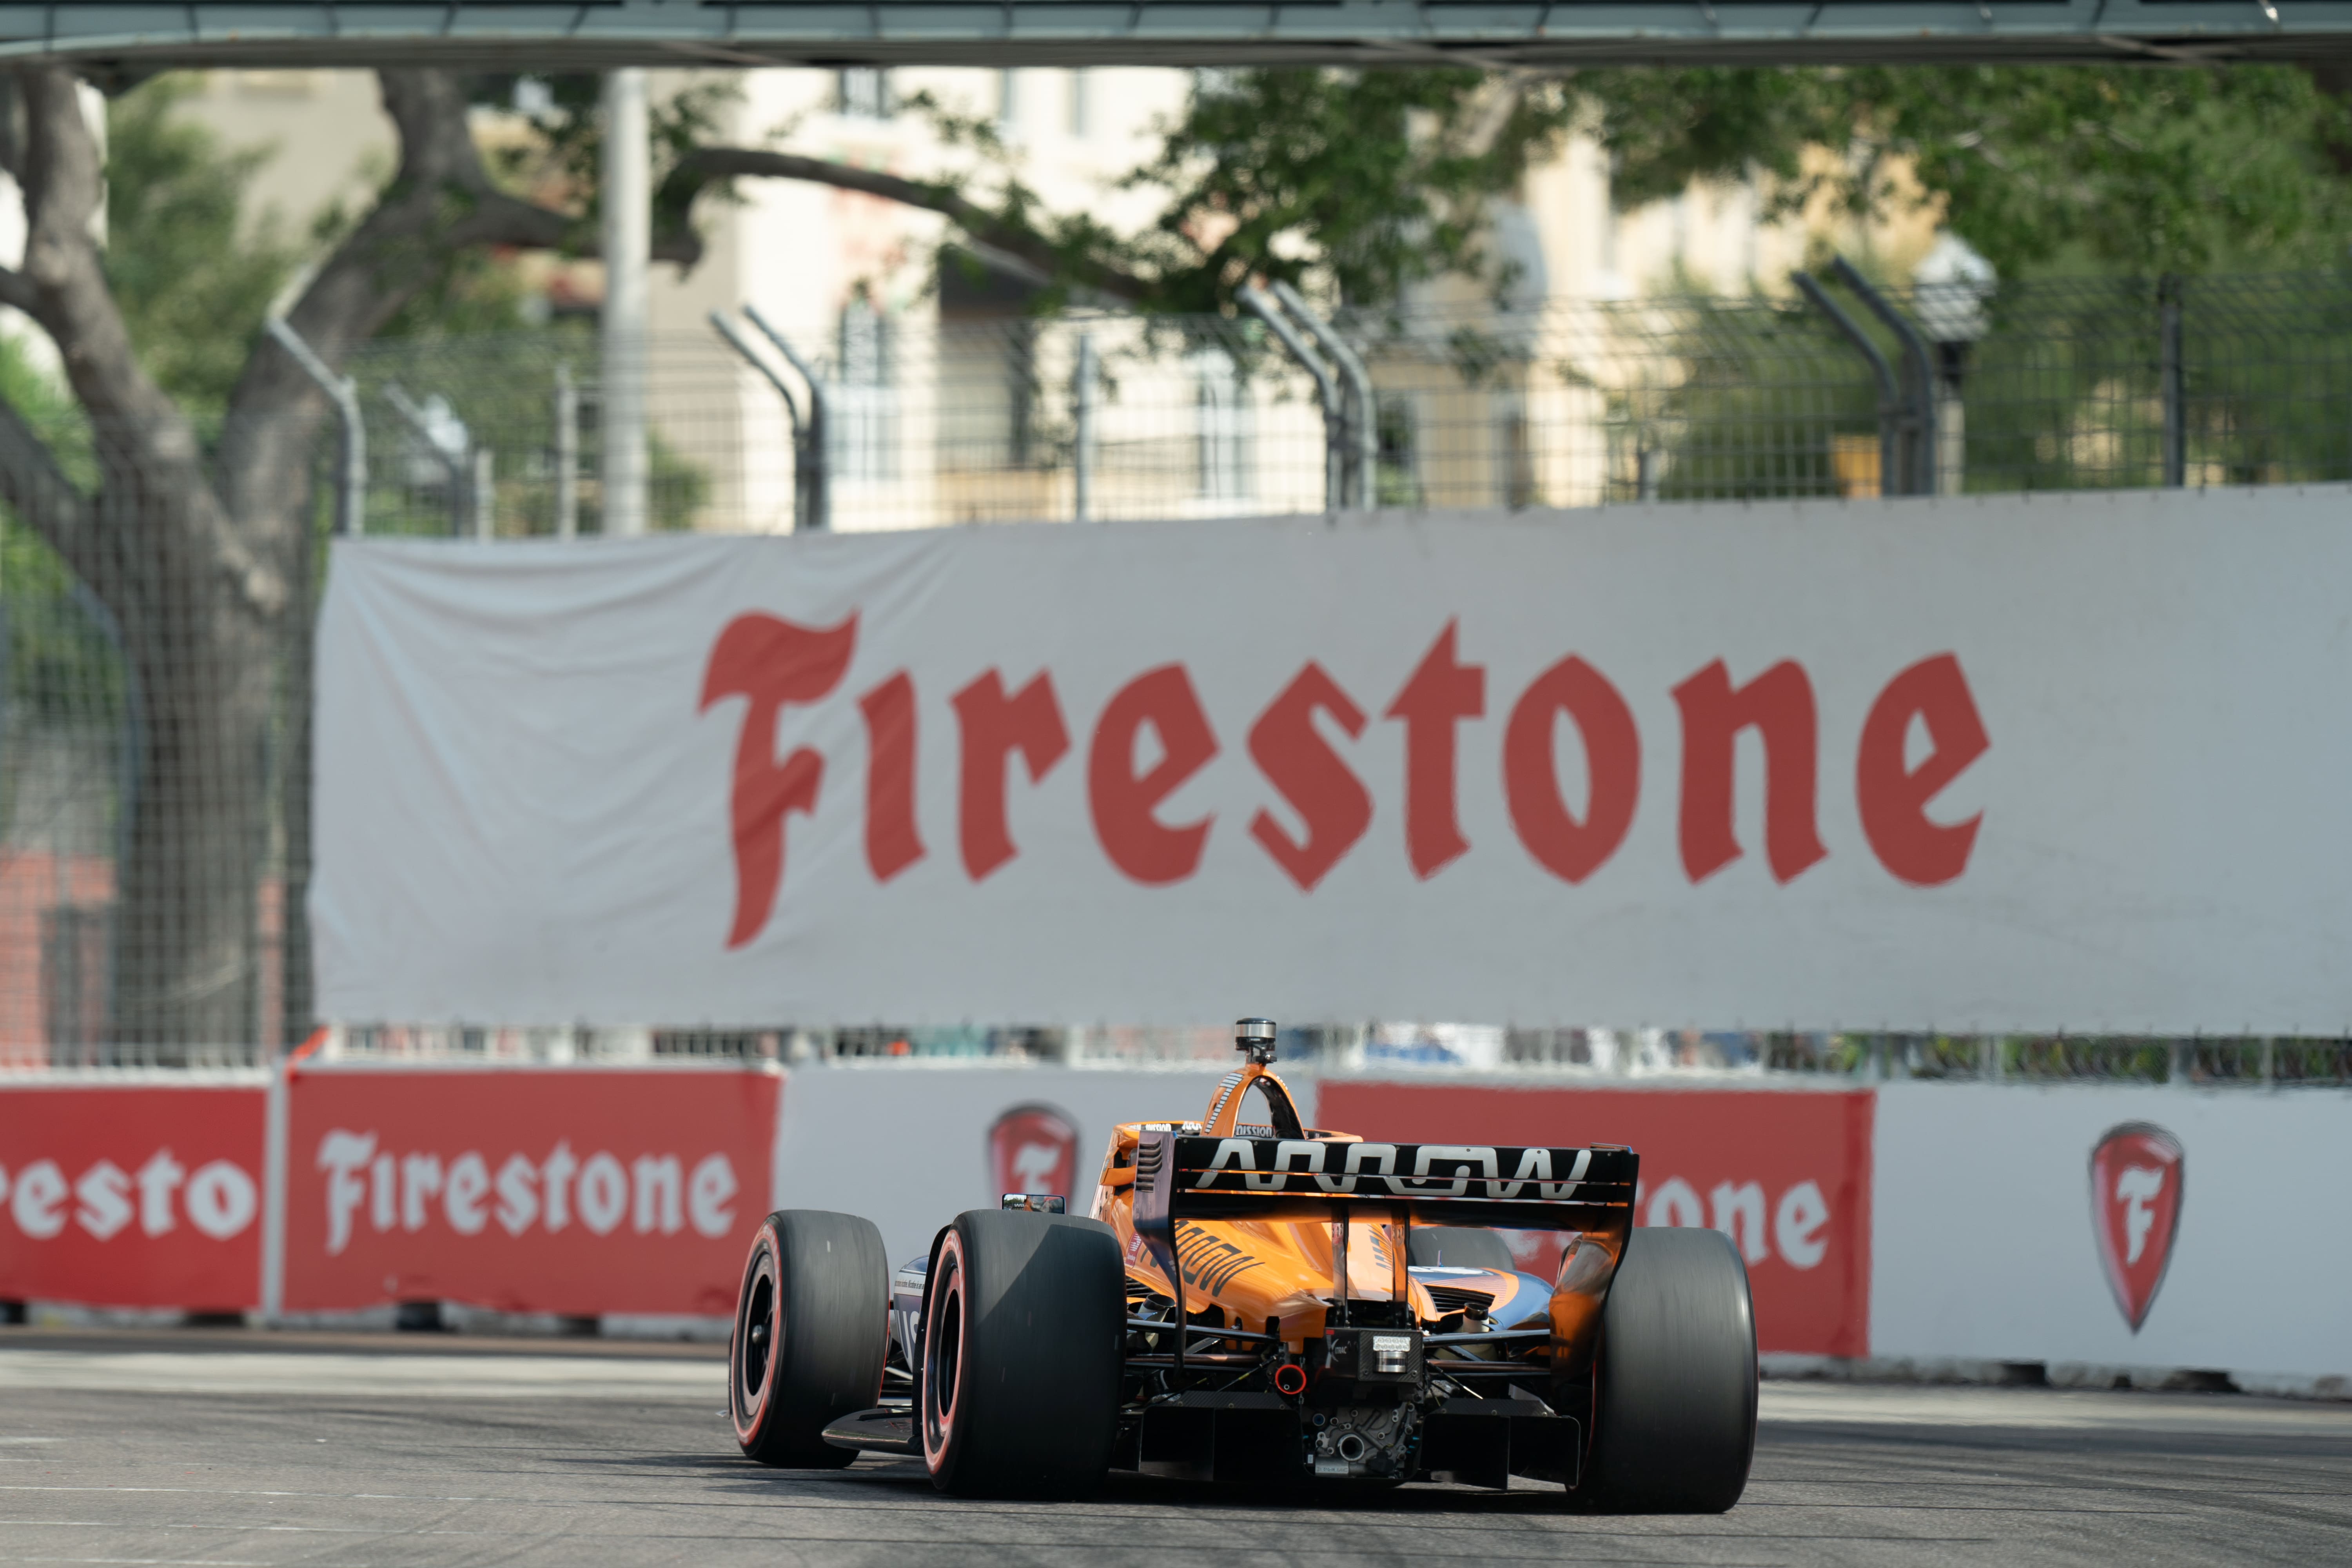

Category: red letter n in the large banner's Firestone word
[1675, 658, 1830, 882]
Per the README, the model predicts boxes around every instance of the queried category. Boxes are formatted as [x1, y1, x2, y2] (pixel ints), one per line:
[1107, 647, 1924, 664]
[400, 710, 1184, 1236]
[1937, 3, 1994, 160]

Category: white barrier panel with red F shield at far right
[1870, 1084, 2352, 1392]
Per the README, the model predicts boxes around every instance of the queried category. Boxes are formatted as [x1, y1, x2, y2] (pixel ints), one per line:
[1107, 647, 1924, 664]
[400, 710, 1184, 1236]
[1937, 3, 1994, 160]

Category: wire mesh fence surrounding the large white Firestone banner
[14, 273, 2352, 1084]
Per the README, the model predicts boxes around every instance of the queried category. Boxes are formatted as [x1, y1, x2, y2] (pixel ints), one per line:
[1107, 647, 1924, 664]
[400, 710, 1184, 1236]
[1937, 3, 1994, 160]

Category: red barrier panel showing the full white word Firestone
[285, 1067, 783, 1316]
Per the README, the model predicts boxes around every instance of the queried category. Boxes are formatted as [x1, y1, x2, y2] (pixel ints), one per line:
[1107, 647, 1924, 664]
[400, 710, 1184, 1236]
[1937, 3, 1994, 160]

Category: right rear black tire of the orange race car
[1581, 1227, 1757, 1514]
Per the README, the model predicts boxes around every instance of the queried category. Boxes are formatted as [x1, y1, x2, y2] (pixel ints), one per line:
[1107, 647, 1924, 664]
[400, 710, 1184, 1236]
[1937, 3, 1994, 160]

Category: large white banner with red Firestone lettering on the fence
[310, 486, 2352, 1032]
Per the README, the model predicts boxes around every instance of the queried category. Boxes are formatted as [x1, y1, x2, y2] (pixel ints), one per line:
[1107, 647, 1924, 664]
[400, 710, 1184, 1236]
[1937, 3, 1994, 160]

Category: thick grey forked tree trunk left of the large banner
[0, 66, 687, 1056]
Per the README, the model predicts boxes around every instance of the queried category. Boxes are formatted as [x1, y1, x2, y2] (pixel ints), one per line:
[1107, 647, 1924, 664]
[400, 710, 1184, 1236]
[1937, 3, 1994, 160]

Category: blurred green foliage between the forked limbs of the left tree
[106, 75, 299, 414]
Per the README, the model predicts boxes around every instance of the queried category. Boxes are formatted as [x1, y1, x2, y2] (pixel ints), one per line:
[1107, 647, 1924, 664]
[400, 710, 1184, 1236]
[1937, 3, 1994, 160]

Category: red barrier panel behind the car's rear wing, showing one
[1315, 1079, 1872, 1356]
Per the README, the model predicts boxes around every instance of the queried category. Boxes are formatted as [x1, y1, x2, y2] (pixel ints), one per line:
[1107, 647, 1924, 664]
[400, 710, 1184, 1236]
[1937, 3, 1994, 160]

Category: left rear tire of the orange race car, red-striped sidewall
[915, 1208, 1127, 1497]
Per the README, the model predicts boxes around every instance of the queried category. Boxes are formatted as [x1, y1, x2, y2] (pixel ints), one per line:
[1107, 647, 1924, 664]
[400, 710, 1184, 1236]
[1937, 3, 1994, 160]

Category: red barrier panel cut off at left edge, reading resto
[0, 1084, 268, 1312]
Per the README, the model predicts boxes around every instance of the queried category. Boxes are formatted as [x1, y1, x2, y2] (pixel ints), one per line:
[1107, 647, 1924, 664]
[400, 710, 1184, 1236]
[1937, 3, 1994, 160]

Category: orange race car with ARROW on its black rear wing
[727, 1018, 1757, 1512]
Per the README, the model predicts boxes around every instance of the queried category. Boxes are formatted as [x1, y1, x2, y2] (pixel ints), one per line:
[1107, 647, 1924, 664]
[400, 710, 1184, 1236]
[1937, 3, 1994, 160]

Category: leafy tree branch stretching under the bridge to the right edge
[640, 64, 2352, 310]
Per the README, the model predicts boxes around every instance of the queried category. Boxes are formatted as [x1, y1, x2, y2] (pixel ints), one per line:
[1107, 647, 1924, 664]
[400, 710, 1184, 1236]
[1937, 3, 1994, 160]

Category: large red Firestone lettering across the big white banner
[701, 613, 1992, 947]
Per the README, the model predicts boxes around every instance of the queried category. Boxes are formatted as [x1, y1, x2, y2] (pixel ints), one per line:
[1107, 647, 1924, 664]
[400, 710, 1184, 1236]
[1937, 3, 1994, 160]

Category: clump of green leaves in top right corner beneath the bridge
[1576, 66, 2352, 278]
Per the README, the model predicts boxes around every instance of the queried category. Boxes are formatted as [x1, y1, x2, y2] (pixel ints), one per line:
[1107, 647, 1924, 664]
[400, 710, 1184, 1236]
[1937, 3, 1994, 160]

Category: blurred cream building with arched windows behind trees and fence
[147, 68, 1931, 531]
